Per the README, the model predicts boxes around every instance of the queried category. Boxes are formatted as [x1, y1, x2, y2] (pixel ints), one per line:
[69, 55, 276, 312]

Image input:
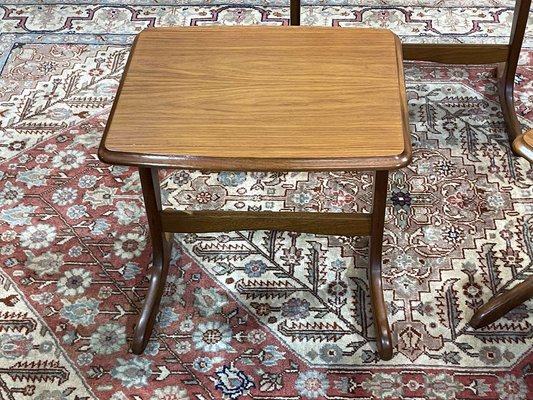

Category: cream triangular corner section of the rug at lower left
[0, 270, 94, 400]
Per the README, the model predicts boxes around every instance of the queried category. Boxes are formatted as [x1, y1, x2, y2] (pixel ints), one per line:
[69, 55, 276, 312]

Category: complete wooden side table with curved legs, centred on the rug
[98, 27, 411, 359]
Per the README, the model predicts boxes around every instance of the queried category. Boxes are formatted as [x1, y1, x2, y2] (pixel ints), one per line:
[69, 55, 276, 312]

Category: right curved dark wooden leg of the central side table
[369, 171, 392, 360]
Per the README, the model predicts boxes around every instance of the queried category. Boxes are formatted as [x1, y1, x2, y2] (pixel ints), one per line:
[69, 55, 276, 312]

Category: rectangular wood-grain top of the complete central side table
[99, 26, 410, 170]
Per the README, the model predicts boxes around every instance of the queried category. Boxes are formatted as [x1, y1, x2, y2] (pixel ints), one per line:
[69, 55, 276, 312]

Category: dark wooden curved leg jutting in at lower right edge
[470, 276, 533, 329]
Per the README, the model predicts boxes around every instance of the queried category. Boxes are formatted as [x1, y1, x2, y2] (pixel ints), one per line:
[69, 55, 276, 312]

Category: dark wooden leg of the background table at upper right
[498, 0, 531, 142]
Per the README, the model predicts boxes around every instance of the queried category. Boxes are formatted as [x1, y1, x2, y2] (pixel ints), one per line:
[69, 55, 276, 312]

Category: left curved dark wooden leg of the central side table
[131, 168, 170, 354]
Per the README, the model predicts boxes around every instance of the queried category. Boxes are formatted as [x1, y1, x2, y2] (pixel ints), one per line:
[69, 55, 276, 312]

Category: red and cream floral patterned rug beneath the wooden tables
[0, 0, 533, 400]
